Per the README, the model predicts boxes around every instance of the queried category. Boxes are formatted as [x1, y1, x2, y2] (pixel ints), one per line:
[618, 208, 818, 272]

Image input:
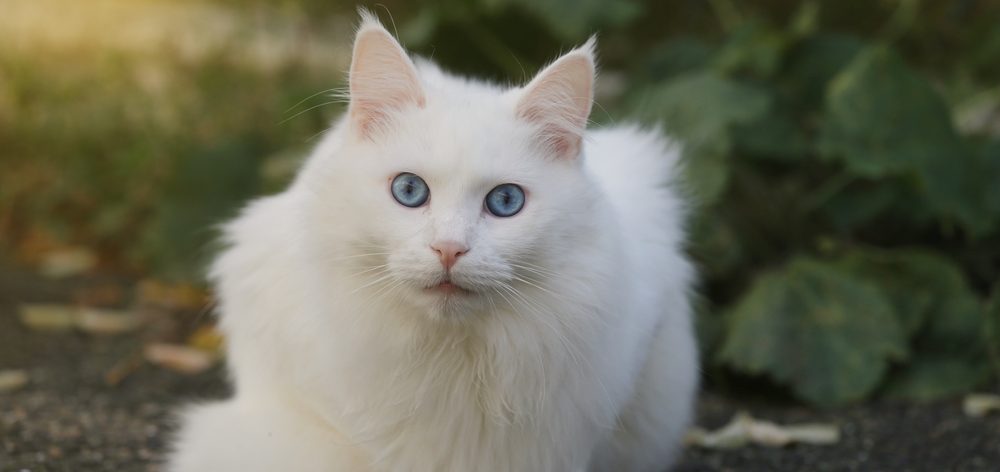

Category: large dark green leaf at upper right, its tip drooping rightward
[819, 46, 992, 234]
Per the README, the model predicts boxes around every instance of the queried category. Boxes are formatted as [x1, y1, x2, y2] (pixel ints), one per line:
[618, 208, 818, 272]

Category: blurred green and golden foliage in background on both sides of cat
[0, 0, 1000, 405]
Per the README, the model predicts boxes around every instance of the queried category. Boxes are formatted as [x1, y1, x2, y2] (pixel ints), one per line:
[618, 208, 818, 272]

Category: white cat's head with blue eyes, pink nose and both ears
[302, 15, 600, 318]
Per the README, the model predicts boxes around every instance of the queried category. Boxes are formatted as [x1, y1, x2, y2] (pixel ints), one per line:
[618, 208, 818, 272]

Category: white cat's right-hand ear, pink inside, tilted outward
[517, 37, 596, 158]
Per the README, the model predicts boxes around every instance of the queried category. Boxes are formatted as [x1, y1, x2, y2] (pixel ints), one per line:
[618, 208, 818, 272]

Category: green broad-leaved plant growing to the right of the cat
[616, 4, 1000, 405]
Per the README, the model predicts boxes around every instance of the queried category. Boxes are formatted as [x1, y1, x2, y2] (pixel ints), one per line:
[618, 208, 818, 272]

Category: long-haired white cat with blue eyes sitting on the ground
[167, 14, 698, 472]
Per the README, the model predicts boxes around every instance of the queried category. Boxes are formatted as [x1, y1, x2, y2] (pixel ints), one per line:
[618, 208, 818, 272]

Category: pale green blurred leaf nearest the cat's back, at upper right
[636, 72, 770, 204]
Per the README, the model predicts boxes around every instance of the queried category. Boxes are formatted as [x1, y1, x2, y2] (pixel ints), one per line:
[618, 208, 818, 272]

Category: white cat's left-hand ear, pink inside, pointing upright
[349, 10, 425, 139]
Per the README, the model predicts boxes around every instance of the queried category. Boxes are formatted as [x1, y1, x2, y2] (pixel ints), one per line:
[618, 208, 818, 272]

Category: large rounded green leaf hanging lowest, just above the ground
[719, 258, 907, 406]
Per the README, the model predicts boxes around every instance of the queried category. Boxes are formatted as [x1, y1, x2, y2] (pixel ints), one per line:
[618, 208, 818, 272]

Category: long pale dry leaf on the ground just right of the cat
[686, 412, 840, 449]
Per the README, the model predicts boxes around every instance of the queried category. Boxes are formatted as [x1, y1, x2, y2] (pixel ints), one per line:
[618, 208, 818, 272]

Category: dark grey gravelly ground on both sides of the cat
[0, 269, 1000, 472]
